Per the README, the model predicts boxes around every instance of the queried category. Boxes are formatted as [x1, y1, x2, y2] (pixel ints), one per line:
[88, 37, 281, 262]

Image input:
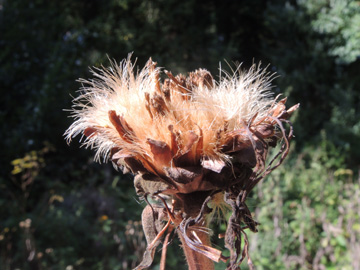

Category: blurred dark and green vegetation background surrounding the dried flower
[0, 0, 360, 270]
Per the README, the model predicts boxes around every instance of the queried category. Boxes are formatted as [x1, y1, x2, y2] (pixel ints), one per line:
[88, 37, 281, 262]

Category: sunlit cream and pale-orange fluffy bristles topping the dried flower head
[65, 53, 277, 165]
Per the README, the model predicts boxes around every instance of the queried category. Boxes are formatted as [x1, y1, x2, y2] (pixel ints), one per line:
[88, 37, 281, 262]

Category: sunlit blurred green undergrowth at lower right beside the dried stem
[250, 142, 360, 269]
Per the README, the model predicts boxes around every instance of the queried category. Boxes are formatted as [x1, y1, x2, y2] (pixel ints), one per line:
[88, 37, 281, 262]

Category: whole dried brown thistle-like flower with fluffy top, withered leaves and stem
[66, 53, 299, 269]
